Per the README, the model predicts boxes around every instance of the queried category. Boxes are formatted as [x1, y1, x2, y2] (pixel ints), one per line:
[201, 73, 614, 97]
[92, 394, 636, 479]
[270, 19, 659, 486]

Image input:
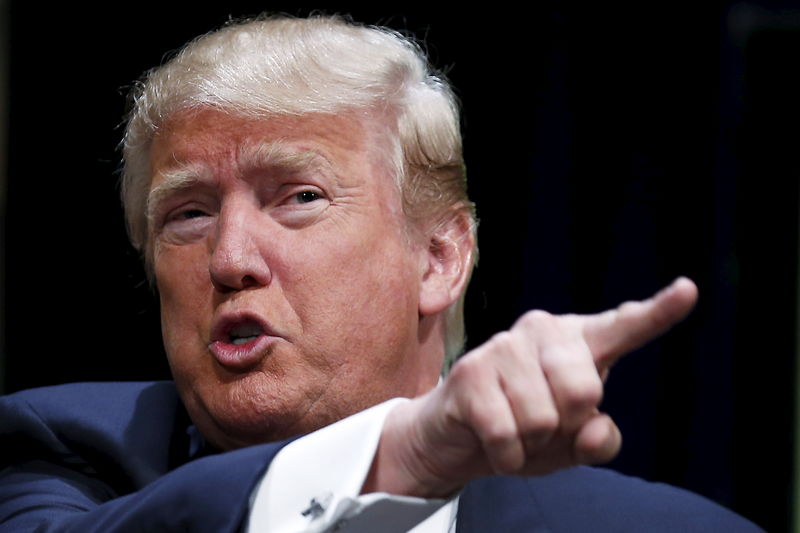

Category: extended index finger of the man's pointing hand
[582, 277, 697, 369]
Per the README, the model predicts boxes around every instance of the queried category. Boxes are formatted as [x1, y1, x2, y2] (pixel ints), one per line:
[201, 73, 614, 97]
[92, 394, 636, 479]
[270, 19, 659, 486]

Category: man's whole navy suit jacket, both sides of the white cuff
[0, 382, 760, 533]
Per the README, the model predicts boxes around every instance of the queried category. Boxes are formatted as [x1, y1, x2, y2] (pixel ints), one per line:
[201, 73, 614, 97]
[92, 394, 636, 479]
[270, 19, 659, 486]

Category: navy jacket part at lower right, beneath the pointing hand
[459, 467, 762, 533]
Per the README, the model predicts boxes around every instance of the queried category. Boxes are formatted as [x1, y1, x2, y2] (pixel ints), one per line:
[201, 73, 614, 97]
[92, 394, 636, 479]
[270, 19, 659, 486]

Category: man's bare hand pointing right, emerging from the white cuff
[364, 278, 697, 497]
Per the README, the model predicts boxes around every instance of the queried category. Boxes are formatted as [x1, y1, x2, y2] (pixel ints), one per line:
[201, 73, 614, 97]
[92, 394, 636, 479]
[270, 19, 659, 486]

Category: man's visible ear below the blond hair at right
[419, 208, 475, 316]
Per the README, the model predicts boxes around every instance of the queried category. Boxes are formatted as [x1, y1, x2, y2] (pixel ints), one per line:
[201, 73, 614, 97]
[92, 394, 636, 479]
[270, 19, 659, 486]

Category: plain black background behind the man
[2, 0, 800, 532]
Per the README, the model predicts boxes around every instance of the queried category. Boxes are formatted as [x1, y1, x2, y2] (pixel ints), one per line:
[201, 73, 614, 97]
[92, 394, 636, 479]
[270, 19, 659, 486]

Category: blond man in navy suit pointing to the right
[0, 14, 756, 532]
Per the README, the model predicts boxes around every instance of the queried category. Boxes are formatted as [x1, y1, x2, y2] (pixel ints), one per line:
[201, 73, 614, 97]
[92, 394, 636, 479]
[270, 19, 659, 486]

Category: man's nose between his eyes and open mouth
[208, 198, 272, 293]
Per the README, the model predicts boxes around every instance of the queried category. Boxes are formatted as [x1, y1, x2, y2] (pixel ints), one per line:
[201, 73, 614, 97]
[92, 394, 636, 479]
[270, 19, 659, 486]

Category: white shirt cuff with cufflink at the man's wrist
[247, 398, 446, 533]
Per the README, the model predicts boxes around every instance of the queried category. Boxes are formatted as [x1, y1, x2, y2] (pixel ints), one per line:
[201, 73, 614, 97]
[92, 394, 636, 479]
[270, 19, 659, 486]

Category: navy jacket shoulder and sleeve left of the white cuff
[0, 384, 285, 533]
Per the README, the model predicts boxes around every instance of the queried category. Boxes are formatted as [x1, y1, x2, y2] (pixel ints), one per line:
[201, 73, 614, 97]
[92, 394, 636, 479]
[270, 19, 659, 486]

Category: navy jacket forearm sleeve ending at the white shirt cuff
[0, 446, 286, 533]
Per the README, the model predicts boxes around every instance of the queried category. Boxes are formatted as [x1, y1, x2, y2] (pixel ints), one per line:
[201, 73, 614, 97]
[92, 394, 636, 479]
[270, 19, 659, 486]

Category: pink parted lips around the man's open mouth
[208, 312, 280, 371]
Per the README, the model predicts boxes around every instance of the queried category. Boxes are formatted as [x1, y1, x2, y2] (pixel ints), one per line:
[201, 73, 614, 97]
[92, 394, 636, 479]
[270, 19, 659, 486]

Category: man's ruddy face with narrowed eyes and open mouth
[149, 110, 441, 448]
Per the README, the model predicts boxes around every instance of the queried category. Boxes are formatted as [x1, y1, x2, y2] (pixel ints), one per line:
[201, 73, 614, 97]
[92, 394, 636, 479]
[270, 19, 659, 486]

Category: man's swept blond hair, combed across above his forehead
[122, 16, 474, 361]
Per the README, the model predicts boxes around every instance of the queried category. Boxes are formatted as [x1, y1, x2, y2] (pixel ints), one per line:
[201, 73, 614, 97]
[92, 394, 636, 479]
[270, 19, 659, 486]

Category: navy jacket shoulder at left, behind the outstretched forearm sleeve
[0, 381, 188, 491]
